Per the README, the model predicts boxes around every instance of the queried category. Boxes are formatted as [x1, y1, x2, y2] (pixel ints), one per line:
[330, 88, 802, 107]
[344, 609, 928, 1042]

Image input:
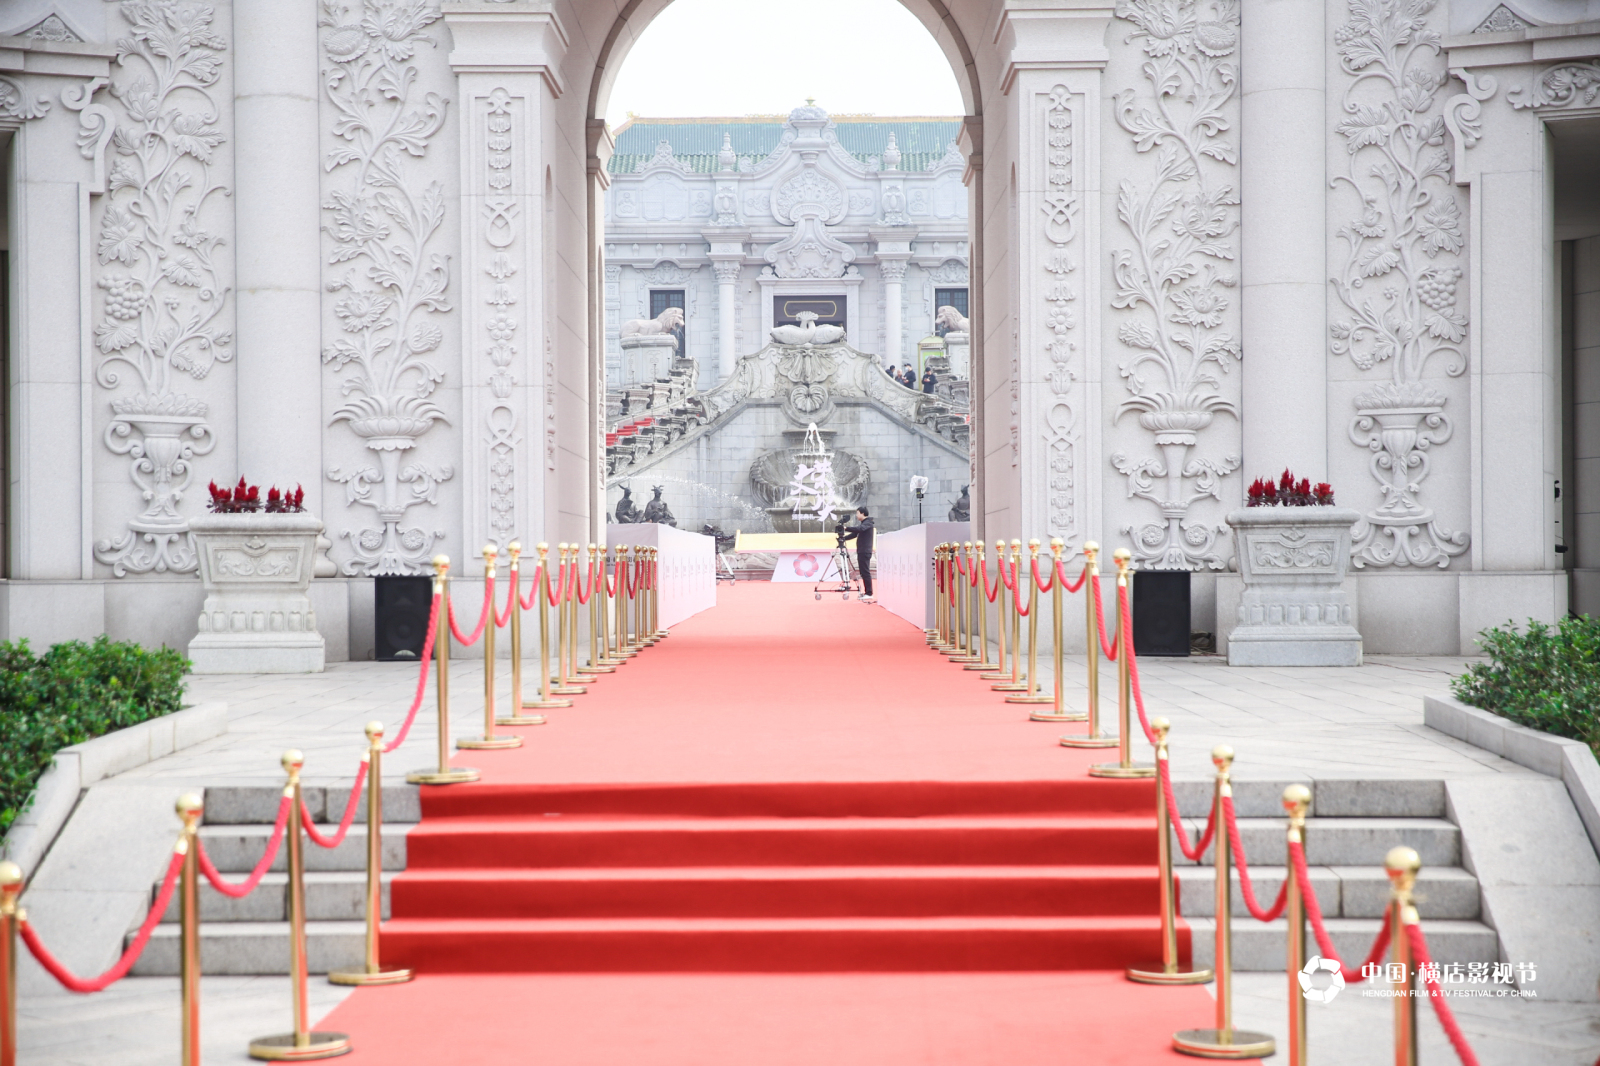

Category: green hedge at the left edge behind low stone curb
[0, 637, 189, 832]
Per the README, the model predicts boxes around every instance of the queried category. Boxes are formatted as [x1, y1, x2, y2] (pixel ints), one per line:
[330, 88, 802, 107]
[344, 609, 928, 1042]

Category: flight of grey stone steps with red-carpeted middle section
[136, 779, 1498, 975]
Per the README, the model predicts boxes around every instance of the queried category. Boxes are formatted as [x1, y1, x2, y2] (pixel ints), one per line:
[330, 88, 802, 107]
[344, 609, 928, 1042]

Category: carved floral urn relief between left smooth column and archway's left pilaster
[322, 0, 454, 575]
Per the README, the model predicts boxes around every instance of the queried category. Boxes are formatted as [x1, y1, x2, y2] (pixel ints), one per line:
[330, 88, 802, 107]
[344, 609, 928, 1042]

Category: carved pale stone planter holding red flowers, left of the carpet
[189, 514, 323, 674]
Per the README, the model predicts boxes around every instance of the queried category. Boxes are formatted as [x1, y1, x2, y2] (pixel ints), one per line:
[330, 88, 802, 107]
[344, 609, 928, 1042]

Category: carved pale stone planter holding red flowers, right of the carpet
[1227, 507, 1362, 666]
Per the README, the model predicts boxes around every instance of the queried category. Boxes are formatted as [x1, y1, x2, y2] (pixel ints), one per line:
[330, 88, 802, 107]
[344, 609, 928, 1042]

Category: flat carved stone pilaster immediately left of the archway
[445, 8, 569, 569]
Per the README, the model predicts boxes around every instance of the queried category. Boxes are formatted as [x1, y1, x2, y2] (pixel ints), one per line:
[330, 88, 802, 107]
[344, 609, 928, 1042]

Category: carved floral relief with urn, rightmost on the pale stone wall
[1331, 0, 1467, 568]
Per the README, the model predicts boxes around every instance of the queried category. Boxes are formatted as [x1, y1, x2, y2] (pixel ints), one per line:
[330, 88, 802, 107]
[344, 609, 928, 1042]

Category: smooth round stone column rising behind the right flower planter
[1238, 0, 1328, 482]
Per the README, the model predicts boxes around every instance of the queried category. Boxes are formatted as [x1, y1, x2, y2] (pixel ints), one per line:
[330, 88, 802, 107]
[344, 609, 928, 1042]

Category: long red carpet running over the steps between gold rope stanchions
[325, 584, 1210, 1066]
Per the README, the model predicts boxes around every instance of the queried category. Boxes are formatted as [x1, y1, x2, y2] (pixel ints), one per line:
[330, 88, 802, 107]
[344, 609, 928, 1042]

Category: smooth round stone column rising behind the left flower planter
[234, 0, 323, 499]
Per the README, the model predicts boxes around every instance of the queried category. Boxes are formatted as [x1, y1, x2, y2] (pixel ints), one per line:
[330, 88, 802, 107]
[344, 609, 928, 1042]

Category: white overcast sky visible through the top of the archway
[606, 0, 965, 130]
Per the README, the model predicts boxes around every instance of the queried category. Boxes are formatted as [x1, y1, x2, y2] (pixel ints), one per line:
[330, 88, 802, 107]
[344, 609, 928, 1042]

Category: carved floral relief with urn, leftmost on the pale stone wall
[90, 0, 234, 578]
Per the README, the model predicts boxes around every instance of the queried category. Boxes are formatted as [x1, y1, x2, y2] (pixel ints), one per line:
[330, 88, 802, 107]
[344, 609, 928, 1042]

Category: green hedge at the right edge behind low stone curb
[1451, 615, 1600, 755]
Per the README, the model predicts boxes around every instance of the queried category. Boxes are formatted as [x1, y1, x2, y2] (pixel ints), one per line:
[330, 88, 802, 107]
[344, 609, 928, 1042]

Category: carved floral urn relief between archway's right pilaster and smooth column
[1110, 0, 1240, 570]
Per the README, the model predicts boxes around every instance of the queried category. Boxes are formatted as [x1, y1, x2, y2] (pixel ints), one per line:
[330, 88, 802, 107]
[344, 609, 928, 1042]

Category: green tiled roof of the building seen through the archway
[606, 115, 962, 174]
